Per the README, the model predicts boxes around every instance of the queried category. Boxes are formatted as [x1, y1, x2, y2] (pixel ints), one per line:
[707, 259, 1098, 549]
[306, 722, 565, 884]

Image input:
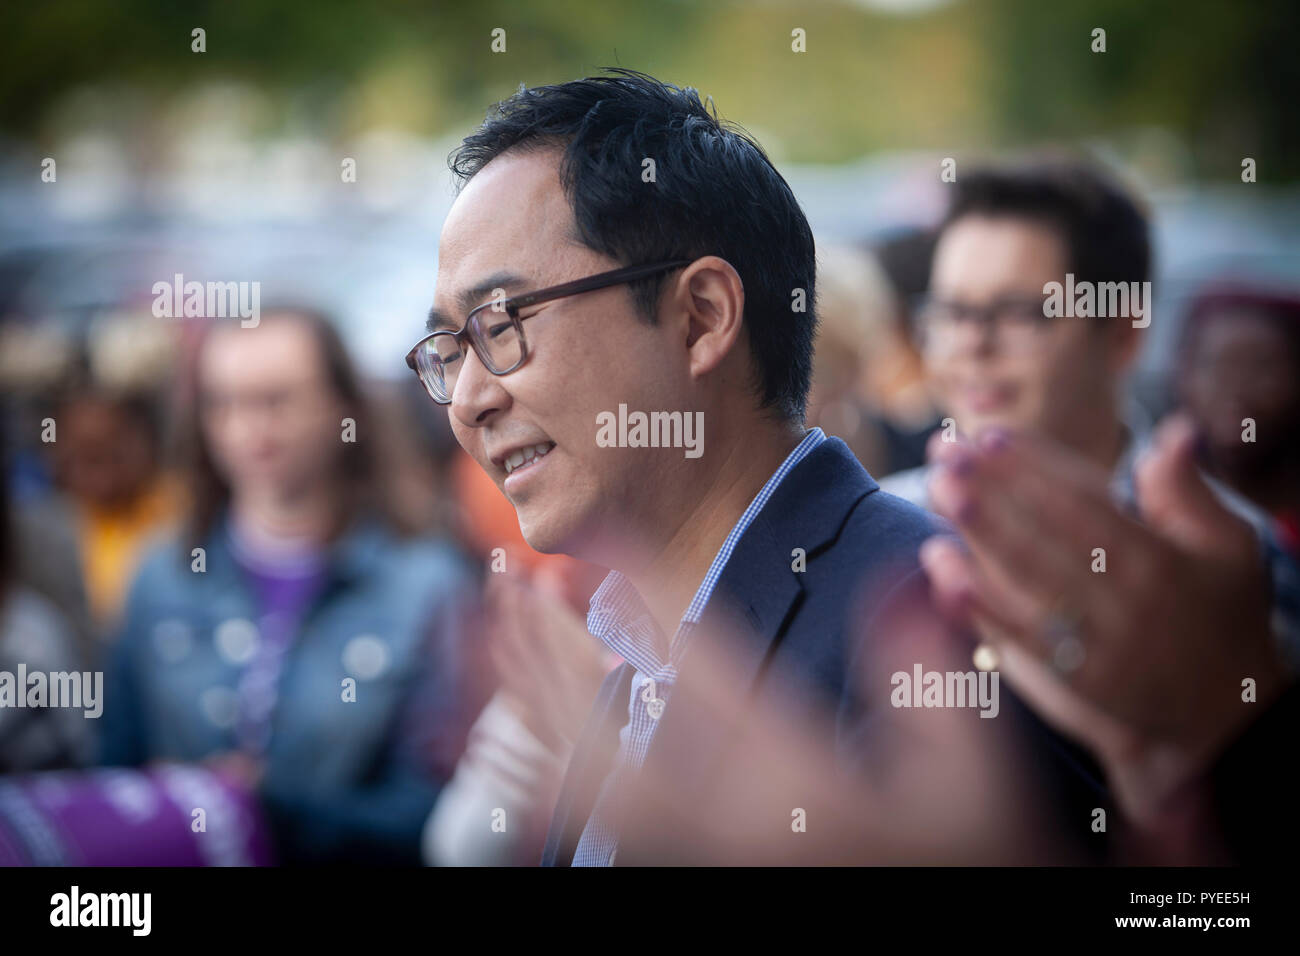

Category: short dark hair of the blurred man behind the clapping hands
[940, 157, 1152, 282]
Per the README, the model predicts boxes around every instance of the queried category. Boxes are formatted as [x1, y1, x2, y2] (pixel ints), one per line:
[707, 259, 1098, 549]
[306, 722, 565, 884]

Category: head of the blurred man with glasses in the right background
[883, 161, 1151, 507]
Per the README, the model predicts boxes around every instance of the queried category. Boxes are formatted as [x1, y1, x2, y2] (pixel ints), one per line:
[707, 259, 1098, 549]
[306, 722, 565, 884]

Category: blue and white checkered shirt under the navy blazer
[573, 428, 826, 866]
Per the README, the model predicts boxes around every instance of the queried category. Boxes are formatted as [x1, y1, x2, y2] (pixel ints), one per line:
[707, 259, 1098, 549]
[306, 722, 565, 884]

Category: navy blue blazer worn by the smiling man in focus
[542, 438, 1109, 866]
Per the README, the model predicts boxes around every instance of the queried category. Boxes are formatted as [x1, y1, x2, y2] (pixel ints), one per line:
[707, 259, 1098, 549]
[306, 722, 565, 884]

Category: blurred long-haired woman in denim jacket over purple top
[103, 310, 475, 862]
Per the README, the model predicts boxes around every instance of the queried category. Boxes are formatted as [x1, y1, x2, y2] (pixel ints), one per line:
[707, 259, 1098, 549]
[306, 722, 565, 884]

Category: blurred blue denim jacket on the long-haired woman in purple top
[100, 520, 475, 864]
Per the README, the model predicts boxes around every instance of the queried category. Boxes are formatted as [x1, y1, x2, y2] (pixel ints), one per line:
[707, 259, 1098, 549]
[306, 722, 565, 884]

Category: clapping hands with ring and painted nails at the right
[922, 418, 1288, 829]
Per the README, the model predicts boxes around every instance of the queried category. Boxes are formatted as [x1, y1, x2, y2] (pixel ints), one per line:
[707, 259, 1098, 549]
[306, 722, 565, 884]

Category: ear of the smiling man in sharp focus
[668, 256, 745, 377]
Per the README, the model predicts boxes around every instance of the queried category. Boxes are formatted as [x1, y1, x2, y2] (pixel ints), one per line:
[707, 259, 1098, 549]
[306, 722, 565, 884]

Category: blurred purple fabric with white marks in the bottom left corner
[0, 765, 274, 866]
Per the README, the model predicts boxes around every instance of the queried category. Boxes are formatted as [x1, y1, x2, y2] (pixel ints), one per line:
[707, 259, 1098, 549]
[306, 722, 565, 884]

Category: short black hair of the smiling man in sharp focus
[450, 69, 816, 421]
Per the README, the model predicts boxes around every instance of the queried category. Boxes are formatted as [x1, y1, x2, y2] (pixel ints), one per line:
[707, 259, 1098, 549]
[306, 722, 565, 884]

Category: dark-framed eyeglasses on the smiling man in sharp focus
[407, 259, 692, 405]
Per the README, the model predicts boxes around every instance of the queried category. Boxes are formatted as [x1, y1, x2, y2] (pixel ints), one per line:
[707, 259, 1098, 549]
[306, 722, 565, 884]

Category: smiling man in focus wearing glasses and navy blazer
[407, 70, 977, 865]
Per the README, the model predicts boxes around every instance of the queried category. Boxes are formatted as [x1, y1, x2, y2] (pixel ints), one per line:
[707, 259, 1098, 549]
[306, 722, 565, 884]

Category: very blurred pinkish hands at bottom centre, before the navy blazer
[605, 582, 1060, 865]
